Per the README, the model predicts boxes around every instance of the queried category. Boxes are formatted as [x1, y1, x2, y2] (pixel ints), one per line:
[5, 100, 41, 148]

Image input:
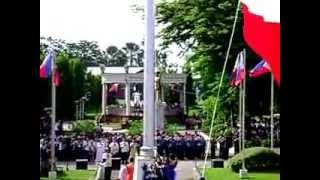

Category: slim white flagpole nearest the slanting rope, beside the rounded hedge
[242, 49, 246, 169]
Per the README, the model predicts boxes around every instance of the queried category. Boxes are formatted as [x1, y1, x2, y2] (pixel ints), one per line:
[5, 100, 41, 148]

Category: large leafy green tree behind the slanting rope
[157, 0, 279, 135]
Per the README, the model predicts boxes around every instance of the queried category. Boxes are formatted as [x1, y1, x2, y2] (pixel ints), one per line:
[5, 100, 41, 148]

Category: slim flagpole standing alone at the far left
[51, 53, 56, 171]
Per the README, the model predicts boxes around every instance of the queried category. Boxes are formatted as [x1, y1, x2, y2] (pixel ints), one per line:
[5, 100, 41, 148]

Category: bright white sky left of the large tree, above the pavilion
[40, 0, 183, 65]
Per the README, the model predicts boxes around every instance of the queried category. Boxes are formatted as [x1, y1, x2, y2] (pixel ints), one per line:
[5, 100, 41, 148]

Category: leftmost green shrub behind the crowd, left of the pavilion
[73, 120, 96, 134]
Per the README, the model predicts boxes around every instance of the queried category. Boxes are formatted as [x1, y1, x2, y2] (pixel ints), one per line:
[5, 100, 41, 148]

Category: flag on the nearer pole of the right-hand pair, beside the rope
[231, 51, 246, 86]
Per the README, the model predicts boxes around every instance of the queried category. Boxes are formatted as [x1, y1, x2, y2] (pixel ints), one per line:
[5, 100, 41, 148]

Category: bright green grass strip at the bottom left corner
[40, 170, 95, 180]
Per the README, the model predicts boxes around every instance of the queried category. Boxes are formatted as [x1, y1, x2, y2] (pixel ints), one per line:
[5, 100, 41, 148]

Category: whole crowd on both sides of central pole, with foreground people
[40, 128, 205, 180]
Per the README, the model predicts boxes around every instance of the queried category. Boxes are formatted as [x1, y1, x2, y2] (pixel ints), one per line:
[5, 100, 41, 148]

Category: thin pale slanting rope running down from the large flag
[201, 0, 240, 177]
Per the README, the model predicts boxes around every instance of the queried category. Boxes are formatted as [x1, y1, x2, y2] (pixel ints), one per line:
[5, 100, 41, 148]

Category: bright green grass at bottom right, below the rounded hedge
[206, 168, 280, 180]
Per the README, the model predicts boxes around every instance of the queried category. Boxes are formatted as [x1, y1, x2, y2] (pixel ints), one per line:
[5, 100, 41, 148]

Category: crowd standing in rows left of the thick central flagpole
[40, 133, 141, 162]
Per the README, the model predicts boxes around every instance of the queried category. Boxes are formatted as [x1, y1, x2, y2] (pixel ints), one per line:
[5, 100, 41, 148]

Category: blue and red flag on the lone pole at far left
[40, 53, 60, 86]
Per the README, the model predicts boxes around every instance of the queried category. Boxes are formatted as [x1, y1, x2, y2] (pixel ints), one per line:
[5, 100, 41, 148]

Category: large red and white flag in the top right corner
[241, 0, 280, 85]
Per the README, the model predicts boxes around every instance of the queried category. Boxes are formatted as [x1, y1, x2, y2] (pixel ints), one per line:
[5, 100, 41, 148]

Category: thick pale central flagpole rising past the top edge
[133, 0, 155, 180]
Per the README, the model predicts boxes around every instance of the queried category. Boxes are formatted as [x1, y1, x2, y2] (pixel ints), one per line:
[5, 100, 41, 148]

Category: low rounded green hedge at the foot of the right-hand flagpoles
[226, 147, 280, 172]
